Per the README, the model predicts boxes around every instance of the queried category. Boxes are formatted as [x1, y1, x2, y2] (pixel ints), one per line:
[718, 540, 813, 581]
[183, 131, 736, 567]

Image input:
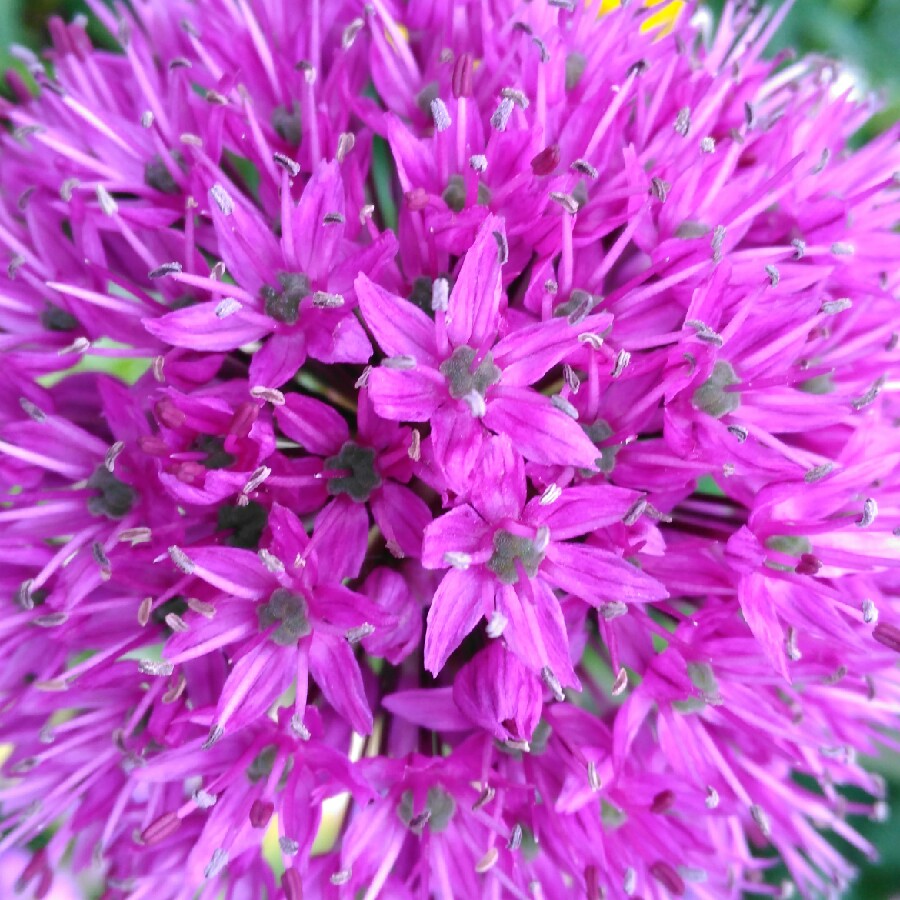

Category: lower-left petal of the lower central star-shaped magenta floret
[425, 569, 494, 675]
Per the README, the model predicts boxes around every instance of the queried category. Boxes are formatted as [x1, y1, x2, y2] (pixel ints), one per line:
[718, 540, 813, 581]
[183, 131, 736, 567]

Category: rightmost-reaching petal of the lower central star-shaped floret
[541, 544, 668, 606]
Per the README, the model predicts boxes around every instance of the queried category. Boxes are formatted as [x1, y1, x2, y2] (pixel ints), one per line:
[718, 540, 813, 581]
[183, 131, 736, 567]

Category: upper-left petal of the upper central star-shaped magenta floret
[355, 273, 439, 368]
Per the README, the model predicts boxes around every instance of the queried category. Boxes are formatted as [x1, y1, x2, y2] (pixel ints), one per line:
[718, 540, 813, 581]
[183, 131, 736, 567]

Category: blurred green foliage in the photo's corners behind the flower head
[0, 0, 900, 900]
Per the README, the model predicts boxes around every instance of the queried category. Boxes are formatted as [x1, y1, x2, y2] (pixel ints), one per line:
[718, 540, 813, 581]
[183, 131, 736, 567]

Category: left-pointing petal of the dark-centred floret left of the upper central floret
[143, 301, 273, 352]
